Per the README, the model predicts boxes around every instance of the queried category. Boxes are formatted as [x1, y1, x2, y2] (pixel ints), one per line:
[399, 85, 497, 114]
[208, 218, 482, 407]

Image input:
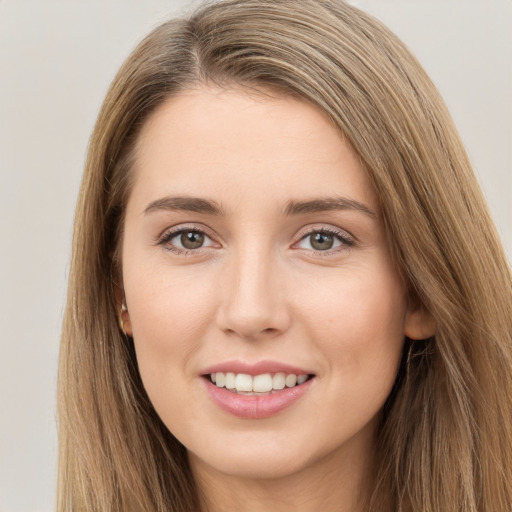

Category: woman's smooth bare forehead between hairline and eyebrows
[129, 87, 377, 212]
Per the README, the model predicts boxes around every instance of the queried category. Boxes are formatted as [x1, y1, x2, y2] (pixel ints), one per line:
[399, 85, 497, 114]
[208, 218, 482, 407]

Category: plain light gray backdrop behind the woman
[0, 0, 512, 512]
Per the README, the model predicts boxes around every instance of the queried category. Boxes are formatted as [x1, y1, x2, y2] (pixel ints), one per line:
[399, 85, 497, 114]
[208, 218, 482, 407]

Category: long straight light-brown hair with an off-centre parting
[58, 0, 512, 512]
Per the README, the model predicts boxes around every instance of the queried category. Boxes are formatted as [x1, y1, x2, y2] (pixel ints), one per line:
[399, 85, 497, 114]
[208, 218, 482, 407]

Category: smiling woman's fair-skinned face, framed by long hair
[122, 88, 428, 478]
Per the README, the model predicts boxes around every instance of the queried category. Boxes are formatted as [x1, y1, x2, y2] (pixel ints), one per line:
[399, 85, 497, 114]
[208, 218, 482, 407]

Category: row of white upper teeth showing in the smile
[210, 372, 308, 393]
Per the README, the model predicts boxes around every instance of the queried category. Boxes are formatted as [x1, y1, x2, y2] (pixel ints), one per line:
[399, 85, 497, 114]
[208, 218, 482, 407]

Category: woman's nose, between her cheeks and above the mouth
[217, 244, 291, 340]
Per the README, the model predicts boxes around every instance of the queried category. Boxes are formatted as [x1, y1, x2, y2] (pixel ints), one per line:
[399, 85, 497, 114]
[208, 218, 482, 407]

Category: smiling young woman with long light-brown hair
[59, 0, 512, 512]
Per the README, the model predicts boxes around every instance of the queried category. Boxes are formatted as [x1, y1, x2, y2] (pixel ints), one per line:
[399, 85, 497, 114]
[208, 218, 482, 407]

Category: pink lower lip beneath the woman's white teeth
[204, 378, 314, 419]
